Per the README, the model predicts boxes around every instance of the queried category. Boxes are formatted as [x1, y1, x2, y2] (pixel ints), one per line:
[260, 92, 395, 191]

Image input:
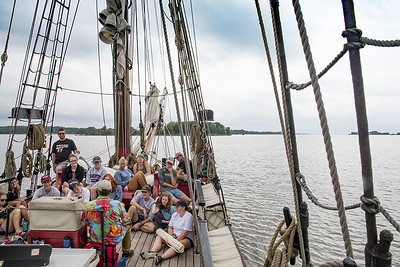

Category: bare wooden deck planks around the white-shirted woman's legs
[118, 231, 200, 267]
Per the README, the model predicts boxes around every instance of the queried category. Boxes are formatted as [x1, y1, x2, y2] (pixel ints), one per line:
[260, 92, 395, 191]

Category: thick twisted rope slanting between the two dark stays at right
[292, 0, 353, 258]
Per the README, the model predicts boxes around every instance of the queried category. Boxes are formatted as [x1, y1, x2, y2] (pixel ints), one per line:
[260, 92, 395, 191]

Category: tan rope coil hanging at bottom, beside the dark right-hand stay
[264, 216, 299, 267]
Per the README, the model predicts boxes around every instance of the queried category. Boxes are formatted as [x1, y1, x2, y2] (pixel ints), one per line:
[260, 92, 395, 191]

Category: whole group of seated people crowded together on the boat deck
[0, 153, 194, 264]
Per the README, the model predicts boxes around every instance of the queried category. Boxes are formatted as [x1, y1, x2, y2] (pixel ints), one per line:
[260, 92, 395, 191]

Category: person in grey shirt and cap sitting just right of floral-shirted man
[128, 185, 155, 233]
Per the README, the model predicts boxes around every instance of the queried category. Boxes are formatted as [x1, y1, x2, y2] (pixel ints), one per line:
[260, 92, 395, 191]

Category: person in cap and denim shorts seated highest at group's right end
[158, 158, 190, 204]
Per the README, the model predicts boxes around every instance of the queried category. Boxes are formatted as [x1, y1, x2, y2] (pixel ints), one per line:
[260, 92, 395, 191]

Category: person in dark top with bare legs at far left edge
[0, 193, 25, 235]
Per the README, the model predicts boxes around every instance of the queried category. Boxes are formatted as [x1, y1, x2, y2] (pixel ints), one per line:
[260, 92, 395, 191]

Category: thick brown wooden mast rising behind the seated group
[113, 1, 131, 158]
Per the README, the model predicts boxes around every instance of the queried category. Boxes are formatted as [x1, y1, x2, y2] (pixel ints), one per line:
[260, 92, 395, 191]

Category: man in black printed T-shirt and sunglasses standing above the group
[51, 128, 80, 177]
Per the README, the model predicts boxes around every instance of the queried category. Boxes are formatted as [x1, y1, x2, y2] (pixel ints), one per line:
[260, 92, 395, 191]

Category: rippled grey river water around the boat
[0, 135, 400, 266]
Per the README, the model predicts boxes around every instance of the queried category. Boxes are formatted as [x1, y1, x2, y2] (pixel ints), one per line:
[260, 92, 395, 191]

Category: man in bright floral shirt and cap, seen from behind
[82, 180, 133, 258]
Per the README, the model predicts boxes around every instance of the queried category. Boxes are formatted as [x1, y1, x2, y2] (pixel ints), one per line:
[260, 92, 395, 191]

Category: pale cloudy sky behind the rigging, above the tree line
[0, 0, 400, 134]
